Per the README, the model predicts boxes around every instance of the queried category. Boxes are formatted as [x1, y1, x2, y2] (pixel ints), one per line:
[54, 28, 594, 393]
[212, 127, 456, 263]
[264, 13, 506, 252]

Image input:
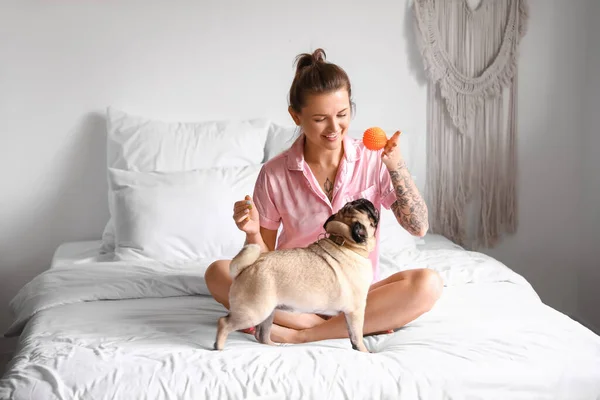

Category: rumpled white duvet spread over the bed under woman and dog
[0, 250, 600, 400]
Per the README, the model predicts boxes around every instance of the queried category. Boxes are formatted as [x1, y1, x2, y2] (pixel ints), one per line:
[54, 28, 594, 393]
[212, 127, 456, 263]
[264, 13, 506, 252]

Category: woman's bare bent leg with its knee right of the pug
[271, 269, 443, 343]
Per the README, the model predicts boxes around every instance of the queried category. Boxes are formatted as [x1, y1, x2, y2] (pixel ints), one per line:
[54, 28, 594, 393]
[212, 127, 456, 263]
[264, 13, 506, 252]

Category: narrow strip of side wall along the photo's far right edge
[579, 0, 600, 332]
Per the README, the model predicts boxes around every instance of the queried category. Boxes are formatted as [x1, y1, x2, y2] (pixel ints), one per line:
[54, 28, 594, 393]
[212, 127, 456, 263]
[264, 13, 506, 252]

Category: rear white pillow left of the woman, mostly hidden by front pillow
[102, 107, 269, 253]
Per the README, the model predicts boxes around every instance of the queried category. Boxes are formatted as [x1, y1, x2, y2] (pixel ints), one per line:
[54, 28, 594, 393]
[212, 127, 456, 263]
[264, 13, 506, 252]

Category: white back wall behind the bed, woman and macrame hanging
[0, 0, 586, 352]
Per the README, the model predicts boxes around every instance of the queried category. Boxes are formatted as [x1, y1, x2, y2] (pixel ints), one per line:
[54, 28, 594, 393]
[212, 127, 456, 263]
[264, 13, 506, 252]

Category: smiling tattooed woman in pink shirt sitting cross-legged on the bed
[206, 49, 443, 343]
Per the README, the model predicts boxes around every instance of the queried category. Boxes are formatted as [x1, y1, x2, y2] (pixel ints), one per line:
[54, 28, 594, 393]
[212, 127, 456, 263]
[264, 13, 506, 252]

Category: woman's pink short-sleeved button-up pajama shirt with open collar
[253, 135, 396, 282]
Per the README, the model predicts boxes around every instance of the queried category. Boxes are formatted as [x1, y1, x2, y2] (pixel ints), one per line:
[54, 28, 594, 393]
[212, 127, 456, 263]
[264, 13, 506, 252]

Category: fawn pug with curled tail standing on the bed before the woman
[214, 199, 379, 352]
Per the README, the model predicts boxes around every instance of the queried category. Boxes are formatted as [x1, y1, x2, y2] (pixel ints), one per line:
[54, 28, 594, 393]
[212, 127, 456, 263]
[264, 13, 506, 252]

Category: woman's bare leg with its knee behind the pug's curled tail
[204, 260, 325, 330]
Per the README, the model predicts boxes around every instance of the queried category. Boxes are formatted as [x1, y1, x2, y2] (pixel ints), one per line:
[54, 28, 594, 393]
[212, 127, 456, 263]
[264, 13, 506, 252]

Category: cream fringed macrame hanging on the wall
[413, 0, 528, 248]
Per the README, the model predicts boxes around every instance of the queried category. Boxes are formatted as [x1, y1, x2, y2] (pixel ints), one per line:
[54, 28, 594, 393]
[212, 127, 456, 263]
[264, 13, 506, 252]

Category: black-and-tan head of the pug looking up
[323, 199, 379, 251]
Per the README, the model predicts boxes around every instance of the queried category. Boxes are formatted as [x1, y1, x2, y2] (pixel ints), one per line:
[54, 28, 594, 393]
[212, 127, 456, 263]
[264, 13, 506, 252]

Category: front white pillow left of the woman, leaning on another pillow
[109, 165, 261, 265]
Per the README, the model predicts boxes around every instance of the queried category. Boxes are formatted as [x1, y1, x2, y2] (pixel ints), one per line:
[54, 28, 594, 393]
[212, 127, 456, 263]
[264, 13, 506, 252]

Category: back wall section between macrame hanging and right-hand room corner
[486, 0, 596, 316]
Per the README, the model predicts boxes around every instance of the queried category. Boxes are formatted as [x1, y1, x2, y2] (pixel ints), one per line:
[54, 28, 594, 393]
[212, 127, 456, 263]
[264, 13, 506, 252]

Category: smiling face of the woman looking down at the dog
[290, 89, 351, 150]
